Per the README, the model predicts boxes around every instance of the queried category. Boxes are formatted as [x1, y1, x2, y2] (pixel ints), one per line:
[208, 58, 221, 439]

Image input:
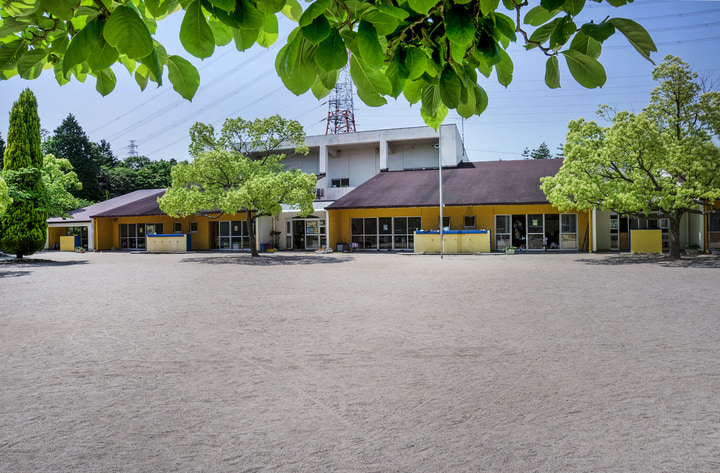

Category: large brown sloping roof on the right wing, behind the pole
[328, 159, 562, 209]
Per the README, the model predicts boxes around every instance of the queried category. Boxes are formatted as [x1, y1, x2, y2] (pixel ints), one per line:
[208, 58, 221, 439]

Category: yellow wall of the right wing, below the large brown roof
[328, 204, 590, 251]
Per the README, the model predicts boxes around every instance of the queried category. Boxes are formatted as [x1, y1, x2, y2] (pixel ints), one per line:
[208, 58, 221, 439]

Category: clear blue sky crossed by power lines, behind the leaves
[0, 0, 720, 161]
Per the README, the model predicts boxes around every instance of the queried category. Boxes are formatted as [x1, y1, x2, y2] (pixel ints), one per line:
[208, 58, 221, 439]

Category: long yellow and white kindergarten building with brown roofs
[47, 125, 720, 251]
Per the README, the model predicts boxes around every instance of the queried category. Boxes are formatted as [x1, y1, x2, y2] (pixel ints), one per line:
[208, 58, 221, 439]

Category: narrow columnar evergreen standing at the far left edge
[0, 89, 47, 258]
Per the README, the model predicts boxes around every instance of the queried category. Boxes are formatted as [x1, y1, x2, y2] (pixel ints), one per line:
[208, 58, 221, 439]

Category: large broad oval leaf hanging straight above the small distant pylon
[103, 5, 153, 59]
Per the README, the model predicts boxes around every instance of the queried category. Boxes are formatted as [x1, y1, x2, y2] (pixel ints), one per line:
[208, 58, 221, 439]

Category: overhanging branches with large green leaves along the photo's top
[0, 0, 657, 128]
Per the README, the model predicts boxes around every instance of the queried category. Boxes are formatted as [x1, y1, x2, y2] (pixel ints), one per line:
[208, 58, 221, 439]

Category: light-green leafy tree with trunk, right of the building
[541, 56, 720, 258]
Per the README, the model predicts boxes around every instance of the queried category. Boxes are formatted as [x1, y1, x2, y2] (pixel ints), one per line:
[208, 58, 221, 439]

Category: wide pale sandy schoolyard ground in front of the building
[0, 252, 720, 473]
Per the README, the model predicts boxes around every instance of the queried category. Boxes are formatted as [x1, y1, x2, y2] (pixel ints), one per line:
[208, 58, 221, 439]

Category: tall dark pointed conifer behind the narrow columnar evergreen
[43, 114, 103, 202]
